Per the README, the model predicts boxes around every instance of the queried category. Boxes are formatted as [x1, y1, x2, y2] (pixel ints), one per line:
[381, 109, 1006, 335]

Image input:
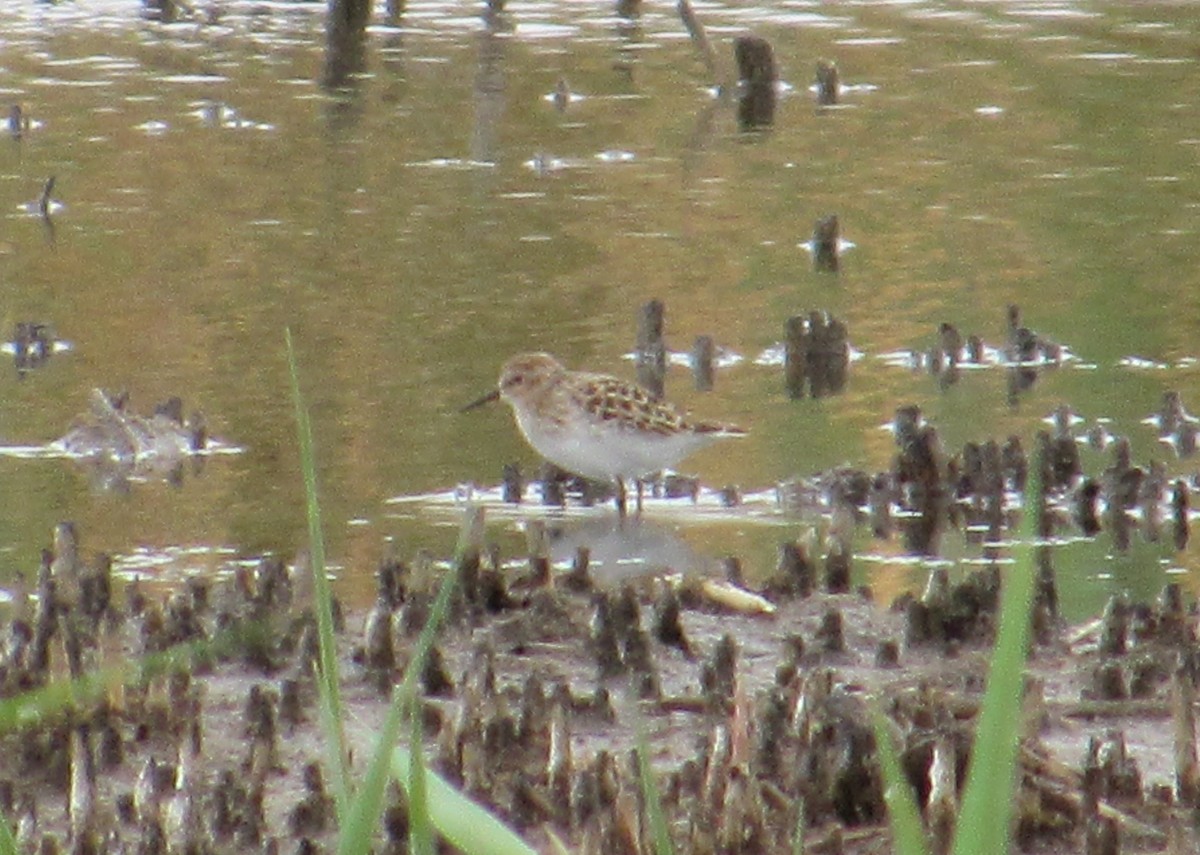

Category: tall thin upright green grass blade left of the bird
[283, 328, 350, 823]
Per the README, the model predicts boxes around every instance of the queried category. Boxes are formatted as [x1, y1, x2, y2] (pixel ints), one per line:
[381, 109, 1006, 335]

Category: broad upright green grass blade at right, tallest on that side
[954, 468, 1042, 855]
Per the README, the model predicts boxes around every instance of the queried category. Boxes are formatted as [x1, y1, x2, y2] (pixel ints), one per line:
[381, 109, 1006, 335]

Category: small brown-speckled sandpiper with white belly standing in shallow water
[463, 353, 745, 510]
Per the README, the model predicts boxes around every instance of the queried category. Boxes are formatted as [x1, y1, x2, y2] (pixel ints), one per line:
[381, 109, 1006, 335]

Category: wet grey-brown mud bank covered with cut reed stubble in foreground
[7, 511, 1200, 853]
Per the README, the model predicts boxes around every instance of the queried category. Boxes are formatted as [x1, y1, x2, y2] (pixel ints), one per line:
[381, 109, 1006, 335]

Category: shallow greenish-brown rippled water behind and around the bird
[0, 2, 1200, 615]
